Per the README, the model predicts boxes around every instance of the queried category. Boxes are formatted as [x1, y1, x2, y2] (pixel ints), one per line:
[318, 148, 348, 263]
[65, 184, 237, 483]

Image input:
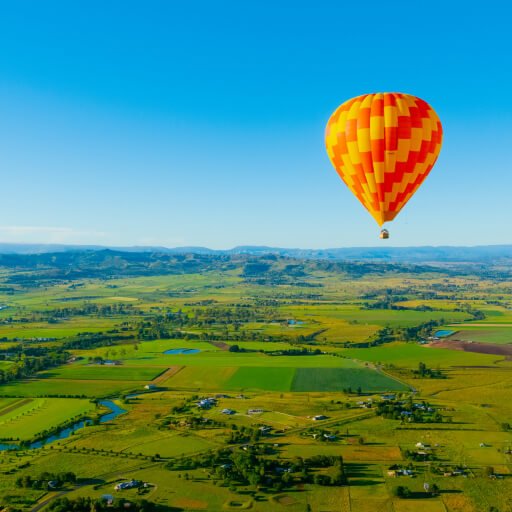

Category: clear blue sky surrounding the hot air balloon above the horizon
[0, 0, 512, 248]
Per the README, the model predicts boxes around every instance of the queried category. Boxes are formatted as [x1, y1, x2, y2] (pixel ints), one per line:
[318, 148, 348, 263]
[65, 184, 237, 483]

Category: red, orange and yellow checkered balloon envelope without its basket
[325, 93, 443, 226]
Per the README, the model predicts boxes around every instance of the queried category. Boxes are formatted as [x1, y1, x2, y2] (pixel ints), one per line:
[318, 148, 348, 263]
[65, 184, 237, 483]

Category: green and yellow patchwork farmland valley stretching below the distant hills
[0, 251, 512, 512]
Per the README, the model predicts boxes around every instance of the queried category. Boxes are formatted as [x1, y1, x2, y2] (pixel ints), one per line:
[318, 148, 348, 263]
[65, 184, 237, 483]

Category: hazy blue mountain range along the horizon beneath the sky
[0, 243, 512, 264]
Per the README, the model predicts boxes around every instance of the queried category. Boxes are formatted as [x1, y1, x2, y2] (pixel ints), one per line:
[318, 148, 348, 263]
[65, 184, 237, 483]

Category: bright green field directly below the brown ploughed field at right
[339, 343, 503, 369]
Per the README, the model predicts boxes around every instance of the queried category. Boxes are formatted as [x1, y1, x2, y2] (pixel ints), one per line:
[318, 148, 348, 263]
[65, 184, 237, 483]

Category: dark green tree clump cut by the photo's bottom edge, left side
[48, 498, 157, 512]
